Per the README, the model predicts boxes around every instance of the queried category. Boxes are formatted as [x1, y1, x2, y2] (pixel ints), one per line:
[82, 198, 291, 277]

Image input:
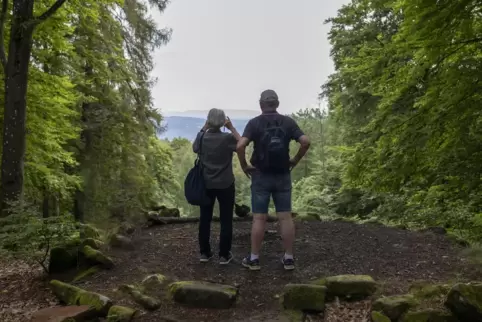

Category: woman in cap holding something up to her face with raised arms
[193, 109, 241, 265]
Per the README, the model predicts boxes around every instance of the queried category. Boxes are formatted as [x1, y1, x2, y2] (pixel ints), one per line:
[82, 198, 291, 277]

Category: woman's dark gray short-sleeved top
[192, 130, 237, 189]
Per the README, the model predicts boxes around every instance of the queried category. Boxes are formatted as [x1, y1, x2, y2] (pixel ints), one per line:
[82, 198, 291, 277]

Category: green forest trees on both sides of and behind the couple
[0, 0, 482, 270]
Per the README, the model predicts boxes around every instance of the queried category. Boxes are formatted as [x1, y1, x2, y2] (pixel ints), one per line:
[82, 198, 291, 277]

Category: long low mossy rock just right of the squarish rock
[325, 275, 377, 299]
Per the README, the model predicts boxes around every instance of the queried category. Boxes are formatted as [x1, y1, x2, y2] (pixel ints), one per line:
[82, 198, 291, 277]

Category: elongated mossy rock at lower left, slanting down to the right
[50, 280, 112, 316]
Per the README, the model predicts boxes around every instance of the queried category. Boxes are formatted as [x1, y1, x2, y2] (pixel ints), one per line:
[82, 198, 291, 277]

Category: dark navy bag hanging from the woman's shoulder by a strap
[184, 133, 211, 206]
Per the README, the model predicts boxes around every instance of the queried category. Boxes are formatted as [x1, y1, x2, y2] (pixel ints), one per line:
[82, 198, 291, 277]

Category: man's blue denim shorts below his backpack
[251, 171, 291, 214]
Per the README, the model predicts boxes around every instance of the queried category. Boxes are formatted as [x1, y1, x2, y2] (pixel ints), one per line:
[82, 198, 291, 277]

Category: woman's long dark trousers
[199, 184, 235, 257]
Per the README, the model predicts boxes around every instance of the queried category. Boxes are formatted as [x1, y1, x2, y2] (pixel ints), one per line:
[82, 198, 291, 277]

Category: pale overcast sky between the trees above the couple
[153, 0, 348, 113]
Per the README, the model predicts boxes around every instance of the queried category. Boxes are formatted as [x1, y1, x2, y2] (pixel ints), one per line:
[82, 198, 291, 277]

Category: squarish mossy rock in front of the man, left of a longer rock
[282, 284, 326, 312]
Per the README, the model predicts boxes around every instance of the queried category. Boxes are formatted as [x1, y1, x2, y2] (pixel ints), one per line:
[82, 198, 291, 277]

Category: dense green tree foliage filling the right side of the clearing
[323, 0, 482, 240]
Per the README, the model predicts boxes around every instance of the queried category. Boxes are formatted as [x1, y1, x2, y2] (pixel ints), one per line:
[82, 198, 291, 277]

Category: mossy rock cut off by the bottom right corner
[445, 283, 482, 321]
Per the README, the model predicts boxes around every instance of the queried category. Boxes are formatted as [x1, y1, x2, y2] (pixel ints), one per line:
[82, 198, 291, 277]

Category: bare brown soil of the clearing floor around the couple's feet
[0, 222, 474, 322]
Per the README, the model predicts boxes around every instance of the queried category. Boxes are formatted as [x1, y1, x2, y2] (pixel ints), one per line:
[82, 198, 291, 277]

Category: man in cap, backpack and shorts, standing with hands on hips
[237, 90, 310, 270]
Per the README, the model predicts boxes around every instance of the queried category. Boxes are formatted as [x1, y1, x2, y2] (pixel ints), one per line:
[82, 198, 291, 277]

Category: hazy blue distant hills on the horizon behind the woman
[160, 116, 249, 140]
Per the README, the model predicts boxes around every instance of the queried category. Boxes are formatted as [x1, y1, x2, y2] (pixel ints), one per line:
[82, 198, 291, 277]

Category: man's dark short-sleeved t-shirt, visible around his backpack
[243, 112, 304, 172]
